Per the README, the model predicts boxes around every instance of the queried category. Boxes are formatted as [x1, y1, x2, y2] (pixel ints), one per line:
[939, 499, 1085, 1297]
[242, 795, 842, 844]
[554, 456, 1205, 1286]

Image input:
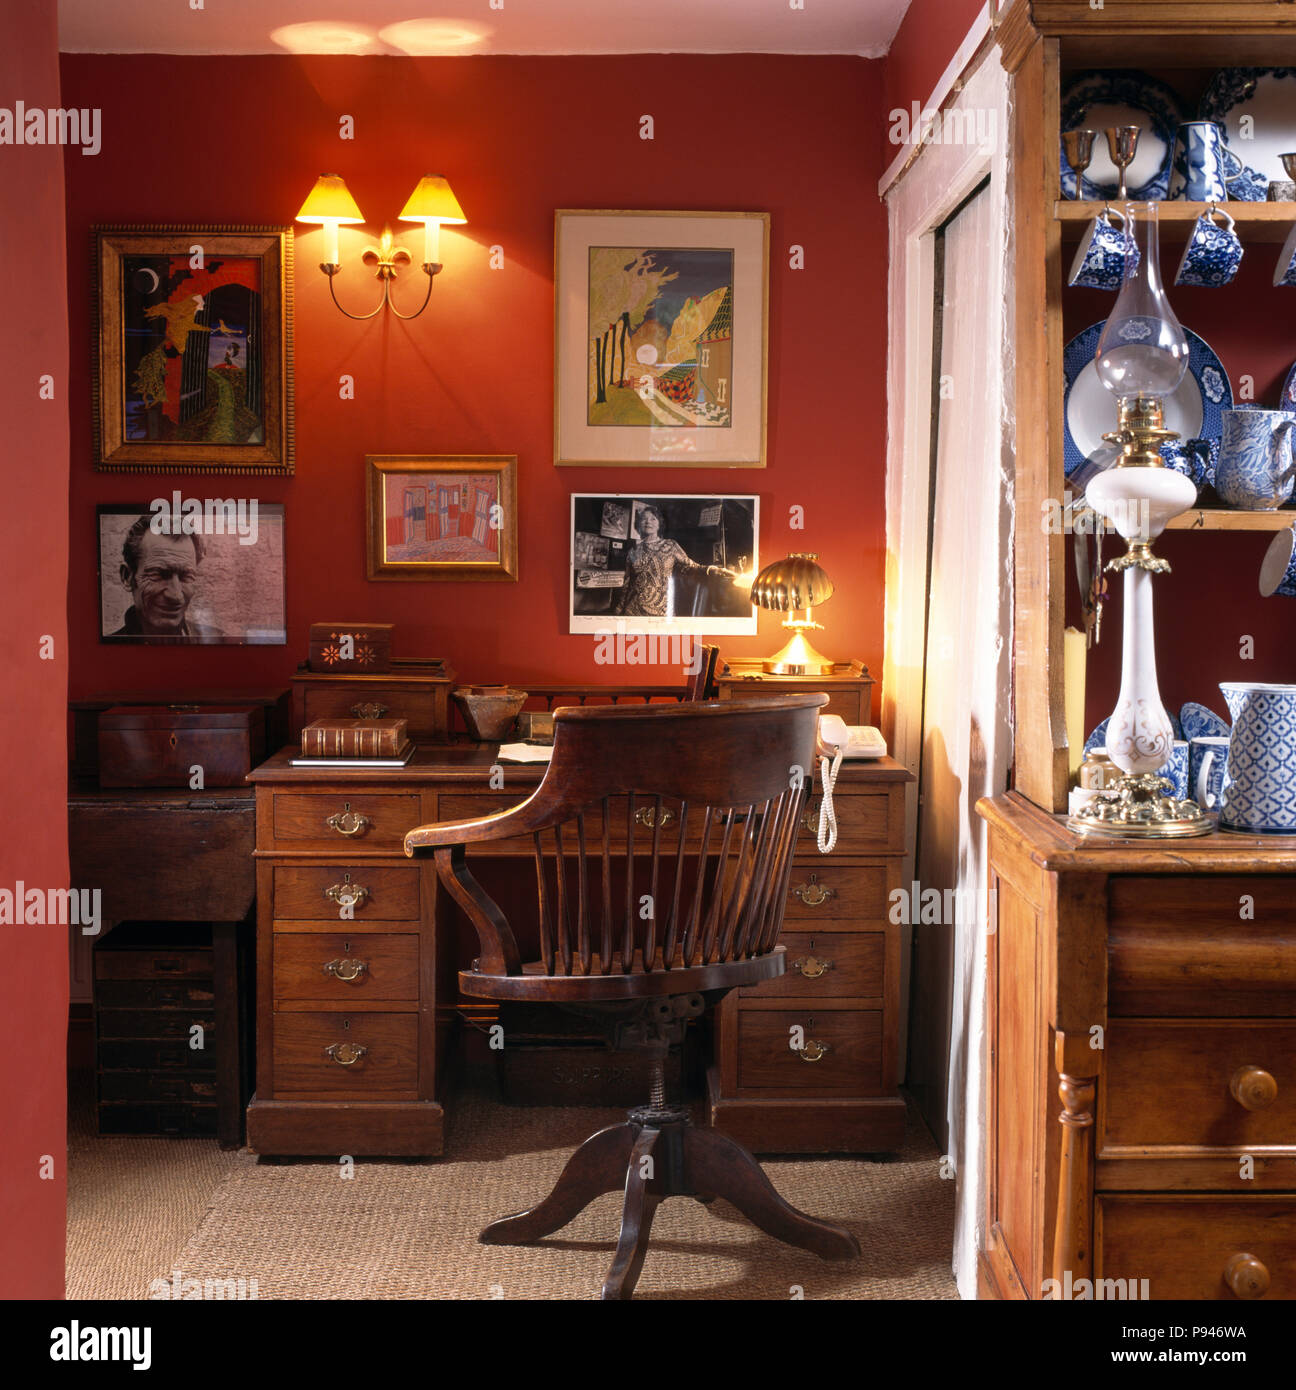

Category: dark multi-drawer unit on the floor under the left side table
[95, 922, 217, 1134]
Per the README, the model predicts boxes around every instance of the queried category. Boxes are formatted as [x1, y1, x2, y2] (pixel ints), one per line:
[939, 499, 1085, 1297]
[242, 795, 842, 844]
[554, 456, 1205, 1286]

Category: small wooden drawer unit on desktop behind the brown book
[292, 659, 455, 744]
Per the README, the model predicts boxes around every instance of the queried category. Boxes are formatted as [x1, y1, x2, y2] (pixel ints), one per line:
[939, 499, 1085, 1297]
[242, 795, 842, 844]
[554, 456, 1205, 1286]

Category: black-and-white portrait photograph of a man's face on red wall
[99, 505, 288, 646]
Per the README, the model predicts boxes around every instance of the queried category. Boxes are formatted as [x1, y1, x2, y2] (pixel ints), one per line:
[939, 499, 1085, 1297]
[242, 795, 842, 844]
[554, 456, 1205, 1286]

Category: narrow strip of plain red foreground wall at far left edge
[0, 6, 70, 1298]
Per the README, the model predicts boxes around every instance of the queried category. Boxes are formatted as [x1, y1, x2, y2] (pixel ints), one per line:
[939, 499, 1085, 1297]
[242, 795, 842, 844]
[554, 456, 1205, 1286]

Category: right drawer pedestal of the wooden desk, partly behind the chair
[708, 758, 911, 1154]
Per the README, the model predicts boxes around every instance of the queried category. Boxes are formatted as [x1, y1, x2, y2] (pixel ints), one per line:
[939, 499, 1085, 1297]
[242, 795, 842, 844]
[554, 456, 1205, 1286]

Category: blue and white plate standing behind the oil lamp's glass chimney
[1062, 318, 1233, 478]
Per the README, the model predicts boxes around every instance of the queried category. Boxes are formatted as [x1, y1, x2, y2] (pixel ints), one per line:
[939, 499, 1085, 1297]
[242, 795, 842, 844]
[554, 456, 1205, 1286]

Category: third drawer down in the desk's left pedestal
[274, 931, 419, 1001]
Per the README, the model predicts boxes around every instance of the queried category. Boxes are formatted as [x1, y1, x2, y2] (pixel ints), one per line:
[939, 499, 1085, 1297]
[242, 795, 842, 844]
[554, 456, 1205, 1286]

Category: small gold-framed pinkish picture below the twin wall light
[364, 453, 517, 581]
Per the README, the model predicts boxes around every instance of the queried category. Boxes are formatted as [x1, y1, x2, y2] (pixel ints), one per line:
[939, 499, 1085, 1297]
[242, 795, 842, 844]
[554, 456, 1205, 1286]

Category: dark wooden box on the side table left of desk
[99, 705, 266, 790]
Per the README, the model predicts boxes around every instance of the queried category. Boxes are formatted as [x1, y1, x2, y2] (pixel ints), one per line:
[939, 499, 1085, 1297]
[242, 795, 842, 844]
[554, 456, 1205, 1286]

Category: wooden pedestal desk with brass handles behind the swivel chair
[248, 742, 908, 1155]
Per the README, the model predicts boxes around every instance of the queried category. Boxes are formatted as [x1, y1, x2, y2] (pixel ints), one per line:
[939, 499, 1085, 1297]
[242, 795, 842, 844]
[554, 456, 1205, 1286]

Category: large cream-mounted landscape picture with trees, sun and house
[553, 210, 769, 468]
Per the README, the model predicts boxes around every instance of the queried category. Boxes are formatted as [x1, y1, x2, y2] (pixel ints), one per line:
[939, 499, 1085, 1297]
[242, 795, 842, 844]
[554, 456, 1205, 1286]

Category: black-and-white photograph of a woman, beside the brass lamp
[567, 492, 761, 635]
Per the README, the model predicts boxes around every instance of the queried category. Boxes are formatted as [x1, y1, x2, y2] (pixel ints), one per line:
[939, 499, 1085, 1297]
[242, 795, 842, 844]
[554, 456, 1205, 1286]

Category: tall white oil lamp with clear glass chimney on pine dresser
[1068, 203, 1211, 838]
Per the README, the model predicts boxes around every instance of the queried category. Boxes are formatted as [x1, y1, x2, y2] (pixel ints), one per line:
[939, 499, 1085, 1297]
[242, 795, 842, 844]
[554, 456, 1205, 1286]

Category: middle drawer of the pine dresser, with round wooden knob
[1103, 1019, 1296, 1150]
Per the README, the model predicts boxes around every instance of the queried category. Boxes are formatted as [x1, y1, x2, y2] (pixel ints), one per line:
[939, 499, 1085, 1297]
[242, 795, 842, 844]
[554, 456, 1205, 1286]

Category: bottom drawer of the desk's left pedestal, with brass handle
[274, 1013, 419, 1097]
